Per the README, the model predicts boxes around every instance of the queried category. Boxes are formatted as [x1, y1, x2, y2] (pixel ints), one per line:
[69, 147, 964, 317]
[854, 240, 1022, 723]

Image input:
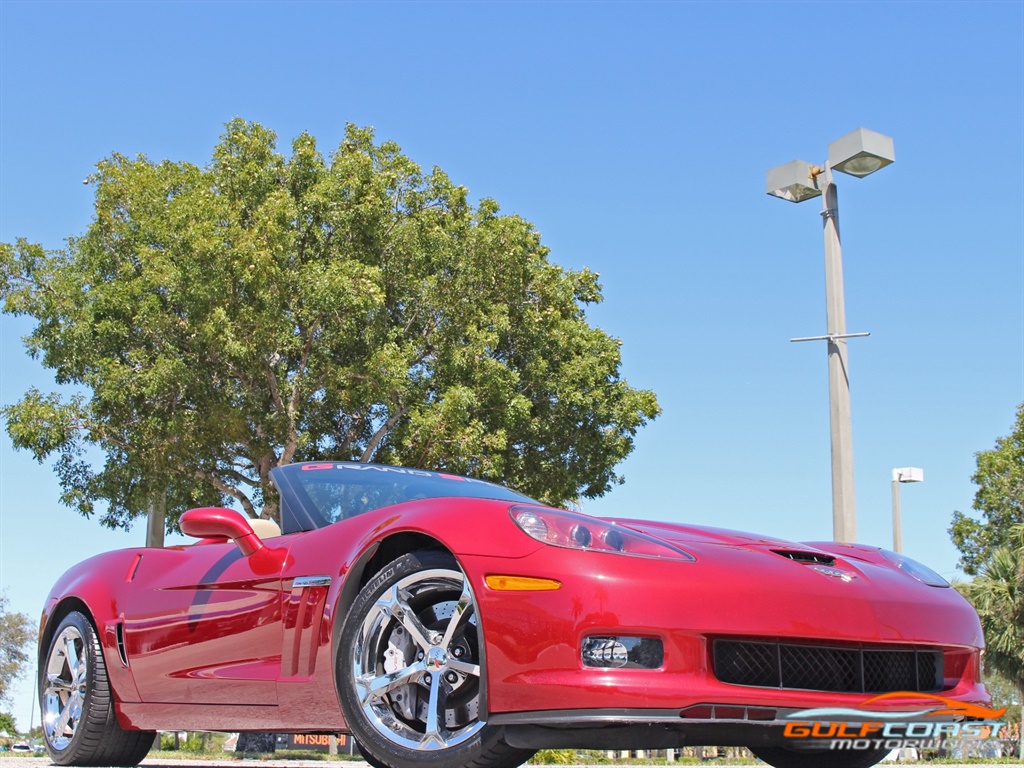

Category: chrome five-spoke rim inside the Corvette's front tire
[351, 567, 484, 752]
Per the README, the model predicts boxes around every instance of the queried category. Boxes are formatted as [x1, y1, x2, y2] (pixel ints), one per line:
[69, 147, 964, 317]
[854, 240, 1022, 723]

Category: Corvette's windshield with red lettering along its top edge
[270, 462, 536, 534]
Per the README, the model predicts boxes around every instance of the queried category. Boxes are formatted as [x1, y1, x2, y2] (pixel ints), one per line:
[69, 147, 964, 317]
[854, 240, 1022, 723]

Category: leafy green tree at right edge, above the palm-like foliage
[949, 403, 1024, 575]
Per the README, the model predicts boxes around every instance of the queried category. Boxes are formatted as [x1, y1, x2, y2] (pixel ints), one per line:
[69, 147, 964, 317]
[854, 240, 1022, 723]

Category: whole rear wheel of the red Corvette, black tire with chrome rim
[39, 611, 157, 766]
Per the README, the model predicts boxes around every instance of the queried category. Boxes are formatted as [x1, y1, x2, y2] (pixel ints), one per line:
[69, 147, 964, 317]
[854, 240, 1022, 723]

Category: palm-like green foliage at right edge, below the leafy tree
[956, 523, 1024, 759]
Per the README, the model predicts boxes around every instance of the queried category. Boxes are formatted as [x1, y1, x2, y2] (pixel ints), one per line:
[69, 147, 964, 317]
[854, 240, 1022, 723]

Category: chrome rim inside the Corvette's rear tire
[40, 626, 89, 751]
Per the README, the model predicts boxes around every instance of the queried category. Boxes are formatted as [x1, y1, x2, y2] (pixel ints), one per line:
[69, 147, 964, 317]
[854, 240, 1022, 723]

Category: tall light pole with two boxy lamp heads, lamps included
[767, 128, 896, 542]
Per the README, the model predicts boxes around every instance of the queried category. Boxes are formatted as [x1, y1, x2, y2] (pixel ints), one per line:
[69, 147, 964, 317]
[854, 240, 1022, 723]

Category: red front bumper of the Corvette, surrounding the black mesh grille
[463, 547, 989, 720]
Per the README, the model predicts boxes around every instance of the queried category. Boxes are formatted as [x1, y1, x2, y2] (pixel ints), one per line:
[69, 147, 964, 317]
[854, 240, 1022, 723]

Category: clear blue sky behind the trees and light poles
[0, 0, 1024, 727]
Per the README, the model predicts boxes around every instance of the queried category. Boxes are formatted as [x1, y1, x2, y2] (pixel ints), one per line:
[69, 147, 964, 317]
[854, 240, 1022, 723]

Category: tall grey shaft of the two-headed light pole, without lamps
[818, 163, 857, 542]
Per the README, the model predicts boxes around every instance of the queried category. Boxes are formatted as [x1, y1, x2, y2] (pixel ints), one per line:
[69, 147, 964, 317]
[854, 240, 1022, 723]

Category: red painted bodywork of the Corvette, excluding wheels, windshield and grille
[37, 499, 988, 731]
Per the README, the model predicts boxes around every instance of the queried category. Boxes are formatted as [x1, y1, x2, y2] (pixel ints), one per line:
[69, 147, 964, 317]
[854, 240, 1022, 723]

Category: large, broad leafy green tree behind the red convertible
[0, 120, 659, 527]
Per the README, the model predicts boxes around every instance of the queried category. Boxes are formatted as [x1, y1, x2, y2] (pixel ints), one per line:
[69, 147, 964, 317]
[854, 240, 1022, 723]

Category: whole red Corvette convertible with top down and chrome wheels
[39, 463, 988, 768]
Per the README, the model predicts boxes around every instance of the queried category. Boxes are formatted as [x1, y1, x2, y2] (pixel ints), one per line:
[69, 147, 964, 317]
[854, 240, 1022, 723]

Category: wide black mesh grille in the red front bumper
[714, 640, 942, 693]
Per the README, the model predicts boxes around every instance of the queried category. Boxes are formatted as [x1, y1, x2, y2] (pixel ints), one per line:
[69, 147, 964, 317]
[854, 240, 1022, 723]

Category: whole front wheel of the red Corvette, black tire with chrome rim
[336, 551, 534, 768]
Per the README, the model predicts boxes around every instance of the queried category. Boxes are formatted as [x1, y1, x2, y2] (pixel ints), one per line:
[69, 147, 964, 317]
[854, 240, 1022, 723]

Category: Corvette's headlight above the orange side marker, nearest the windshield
[509, 507, 696, 562]
